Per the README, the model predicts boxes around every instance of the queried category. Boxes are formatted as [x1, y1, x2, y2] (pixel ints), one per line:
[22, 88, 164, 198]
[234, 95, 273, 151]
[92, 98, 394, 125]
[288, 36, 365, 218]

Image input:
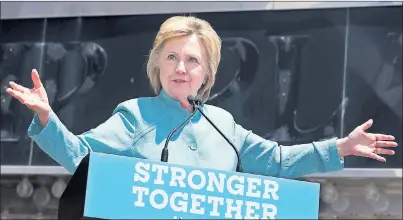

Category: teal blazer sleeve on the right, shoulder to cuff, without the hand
[238, 125, 344, 178]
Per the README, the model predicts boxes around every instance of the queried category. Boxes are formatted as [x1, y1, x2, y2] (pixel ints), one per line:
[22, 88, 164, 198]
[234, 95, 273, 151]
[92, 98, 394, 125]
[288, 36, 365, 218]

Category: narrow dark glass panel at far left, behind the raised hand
[0, 20, 46, 165]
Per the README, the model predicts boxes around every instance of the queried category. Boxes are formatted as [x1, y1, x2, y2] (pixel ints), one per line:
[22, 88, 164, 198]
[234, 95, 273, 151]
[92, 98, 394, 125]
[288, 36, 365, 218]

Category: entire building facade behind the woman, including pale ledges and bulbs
[0, 1, 402, 219]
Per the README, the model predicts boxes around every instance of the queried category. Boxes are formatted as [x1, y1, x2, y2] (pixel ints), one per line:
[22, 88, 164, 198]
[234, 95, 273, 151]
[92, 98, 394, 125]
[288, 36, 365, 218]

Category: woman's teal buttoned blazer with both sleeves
[28, 90, 344, 178]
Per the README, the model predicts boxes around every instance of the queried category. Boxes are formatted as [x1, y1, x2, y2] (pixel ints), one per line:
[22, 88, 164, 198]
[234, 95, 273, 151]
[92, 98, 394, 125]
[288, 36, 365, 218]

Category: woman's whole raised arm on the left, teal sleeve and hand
[7, 69, 140, 172]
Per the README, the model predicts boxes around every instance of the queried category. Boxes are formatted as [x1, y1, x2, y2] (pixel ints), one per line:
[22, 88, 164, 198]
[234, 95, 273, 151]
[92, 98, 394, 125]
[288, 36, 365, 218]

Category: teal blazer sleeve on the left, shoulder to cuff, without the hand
[28, 104, 135, 173]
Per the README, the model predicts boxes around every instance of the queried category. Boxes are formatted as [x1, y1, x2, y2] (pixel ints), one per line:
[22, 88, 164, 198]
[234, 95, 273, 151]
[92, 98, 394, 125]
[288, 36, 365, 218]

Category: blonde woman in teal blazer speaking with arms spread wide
[7, 16, 397, 178]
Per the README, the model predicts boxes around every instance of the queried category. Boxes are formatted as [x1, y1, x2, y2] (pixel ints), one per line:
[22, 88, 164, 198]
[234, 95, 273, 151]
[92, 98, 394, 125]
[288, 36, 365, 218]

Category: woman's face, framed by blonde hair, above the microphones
[159, 35, 207, 100]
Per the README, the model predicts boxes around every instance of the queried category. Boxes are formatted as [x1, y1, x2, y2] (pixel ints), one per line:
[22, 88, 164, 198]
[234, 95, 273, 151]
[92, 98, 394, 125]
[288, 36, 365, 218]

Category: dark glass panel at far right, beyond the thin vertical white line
[344, 7, 402, 168]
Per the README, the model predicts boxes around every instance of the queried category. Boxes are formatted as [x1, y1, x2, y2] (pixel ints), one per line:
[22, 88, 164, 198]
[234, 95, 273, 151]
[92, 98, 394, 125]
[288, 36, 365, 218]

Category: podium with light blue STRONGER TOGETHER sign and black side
[58, 152, 320, 220]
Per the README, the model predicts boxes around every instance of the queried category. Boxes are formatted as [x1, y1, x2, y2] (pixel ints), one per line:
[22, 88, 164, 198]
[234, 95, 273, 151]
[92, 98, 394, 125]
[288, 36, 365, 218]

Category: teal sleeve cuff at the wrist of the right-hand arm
[314, 138, 344, 172]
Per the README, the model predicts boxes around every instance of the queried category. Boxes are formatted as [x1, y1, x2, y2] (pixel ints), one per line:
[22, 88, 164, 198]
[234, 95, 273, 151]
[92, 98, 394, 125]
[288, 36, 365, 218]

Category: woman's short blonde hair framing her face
[147, 16, 221, 101]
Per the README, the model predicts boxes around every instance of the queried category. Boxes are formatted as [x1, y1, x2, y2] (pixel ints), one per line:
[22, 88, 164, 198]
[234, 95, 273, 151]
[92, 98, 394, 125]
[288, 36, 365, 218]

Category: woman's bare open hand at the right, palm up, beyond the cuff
[337, 119, 397, 162]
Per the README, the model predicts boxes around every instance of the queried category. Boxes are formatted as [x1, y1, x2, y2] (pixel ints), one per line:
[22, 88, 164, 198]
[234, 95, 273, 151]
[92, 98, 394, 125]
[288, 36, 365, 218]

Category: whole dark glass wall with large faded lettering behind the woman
[0, 7, 402, 167]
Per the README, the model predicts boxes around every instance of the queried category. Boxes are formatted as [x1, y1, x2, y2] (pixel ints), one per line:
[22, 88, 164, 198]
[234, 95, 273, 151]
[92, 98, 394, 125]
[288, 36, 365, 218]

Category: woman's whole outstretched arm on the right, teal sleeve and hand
[235, 118, 397, 178]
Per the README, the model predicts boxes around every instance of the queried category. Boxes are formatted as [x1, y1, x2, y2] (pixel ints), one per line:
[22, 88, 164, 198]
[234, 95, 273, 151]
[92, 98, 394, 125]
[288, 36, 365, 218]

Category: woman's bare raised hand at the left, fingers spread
[6, 69, 51, 126]
